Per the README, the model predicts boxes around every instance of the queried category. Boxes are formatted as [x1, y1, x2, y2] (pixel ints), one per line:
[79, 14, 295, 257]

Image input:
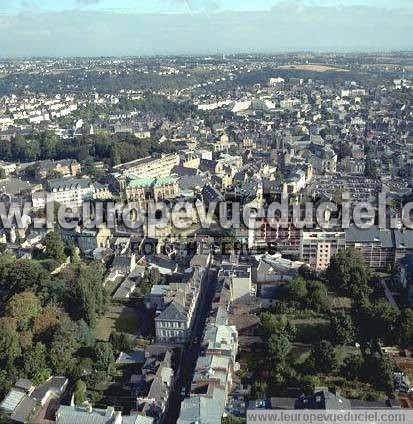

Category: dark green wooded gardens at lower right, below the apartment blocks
[248, 249, 413, 400]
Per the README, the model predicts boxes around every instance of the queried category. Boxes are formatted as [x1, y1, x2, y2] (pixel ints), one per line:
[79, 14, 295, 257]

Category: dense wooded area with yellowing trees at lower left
[0, 233, 115, 394]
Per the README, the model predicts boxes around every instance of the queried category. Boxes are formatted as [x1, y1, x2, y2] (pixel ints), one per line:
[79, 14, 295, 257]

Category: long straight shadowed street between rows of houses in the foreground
[163, 269, 218, 424]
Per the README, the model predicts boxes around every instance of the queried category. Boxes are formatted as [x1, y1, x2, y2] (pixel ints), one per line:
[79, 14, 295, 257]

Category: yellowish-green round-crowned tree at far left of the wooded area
[6, 292, 42, 330]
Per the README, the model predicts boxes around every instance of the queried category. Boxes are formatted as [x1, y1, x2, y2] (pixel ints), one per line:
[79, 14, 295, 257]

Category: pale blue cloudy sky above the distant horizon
[0, 0, 413, 57]
